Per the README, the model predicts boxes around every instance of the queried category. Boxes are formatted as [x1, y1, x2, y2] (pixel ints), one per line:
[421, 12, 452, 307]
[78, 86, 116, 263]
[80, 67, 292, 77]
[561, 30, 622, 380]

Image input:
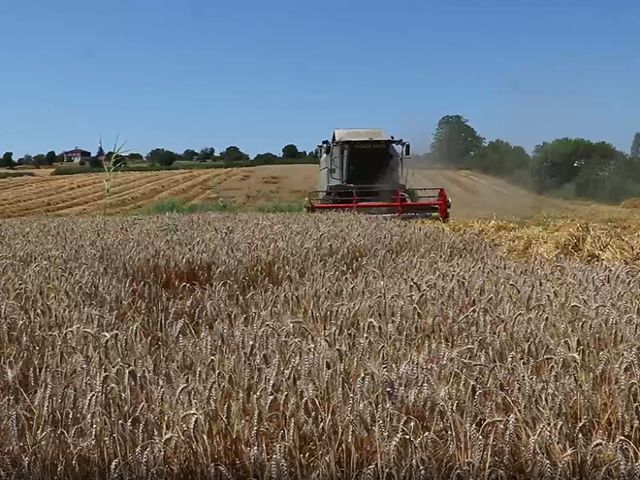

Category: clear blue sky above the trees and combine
[0, 0, 640, 158]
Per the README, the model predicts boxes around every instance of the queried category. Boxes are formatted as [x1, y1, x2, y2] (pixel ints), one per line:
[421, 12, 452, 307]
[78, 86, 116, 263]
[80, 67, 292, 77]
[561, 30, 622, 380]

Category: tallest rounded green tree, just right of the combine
[431, 115, 484, 168]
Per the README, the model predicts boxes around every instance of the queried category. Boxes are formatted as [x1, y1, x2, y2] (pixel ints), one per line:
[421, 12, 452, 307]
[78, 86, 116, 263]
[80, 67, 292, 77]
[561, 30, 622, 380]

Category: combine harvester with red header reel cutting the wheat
[306, 129, 451, 222]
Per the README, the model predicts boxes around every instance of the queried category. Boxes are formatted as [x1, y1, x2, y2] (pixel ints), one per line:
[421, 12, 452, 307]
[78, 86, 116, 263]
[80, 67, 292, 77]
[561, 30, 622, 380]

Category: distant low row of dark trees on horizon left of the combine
[0, 144, 317, 168]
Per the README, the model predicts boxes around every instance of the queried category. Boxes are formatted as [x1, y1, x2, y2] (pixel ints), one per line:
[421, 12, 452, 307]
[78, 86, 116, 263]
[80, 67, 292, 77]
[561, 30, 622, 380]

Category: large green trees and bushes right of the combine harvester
[421, 115, 640, 202]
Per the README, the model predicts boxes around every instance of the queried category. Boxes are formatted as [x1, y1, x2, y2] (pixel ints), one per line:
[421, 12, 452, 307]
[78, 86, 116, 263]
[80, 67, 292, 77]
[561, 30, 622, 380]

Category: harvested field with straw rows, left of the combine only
[0, 165, 317, 218]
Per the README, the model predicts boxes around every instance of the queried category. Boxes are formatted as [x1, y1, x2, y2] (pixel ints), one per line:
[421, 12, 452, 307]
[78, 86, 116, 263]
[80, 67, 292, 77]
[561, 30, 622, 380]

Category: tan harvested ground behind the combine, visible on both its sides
[0, 165, 624, 219]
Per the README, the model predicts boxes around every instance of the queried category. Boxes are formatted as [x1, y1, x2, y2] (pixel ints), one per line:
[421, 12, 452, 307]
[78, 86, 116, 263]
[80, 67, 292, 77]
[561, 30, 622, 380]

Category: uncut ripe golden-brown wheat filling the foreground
[0, 214, 640, 479]
